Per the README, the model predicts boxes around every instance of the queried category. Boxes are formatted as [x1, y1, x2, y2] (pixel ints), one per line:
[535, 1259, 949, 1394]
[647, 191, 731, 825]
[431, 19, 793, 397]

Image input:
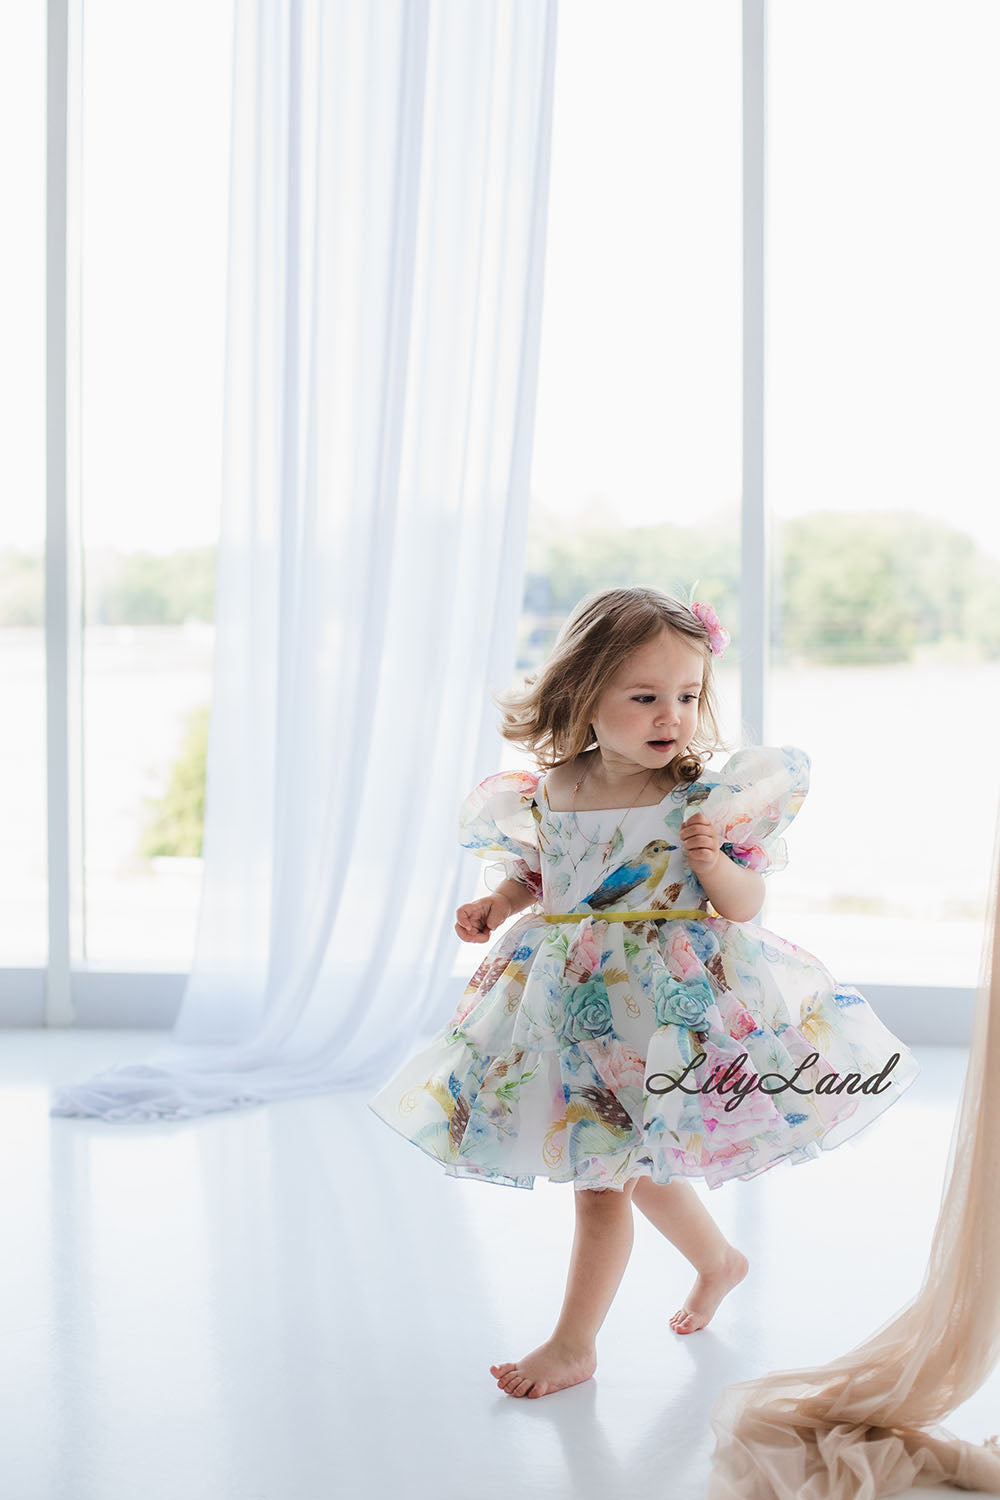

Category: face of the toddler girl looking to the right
[592, 627, 703, 776]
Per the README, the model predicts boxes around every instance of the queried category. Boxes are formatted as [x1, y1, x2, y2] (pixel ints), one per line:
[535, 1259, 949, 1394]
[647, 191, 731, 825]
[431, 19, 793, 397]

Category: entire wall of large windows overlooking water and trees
[11, 0, 1000, 1008]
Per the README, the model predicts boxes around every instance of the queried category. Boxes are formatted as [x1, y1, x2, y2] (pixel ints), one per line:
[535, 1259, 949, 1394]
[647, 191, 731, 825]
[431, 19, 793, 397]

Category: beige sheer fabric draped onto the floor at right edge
[706, 792, 1000, 1500]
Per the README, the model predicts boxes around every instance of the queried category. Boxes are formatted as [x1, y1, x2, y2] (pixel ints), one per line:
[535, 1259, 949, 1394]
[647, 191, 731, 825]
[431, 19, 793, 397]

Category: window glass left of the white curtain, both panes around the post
[0, 0, 232, 971]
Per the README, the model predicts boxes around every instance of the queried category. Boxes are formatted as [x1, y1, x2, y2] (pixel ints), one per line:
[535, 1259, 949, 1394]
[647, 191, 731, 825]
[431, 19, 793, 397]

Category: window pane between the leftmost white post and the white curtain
[76, 0, 232, 969]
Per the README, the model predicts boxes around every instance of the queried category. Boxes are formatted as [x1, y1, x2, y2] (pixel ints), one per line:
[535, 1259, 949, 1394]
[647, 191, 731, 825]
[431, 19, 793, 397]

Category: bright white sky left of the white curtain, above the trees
[0, 0, 232, 551]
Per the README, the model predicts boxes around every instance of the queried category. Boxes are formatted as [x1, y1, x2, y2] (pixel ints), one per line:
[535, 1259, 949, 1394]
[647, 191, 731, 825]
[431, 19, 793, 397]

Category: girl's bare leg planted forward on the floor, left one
[490, 1178, 636, 1397]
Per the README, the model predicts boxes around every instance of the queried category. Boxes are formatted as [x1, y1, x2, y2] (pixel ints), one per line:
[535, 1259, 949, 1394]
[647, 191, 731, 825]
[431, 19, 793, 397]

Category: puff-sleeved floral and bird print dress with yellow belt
[369, 746, 919, 1190]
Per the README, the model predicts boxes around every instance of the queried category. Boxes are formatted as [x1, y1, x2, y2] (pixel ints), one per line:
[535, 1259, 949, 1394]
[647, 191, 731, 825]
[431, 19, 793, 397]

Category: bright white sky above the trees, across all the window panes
[0, 0, 1000, 557]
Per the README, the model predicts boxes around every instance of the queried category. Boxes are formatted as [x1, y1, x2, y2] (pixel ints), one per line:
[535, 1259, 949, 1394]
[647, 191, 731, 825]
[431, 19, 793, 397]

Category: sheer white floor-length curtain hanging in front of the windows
[51, 0, 556, 1121]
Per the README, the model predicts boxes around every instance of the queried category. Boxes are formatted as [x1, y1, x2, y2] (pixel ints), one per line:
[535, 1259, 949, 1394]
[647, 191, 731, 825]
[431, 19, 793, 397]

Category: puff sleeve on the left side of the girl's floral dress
[459, 771, 541, 900]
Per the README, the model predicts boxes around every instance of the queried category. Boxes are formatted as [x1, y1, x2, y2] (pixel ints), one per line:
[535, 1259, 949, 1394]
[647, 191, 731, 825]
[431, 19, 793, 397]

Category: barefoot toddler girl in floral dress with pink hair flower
[370, 588, 919, 1397]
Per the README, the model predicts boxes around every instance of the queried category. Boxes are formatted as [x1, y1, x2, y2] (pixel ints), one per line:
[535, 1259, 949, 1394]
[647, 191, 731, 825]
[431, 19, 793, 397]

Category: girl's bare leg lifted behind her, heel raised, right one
[633, 1178, 750, 1334]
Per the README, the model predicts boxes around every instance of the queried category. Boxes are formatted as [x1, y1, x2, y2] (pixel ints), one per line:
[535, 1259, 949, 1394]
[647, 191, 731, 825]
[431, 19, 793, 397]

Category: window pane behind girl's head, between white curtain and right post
[456, 0, 741, 974]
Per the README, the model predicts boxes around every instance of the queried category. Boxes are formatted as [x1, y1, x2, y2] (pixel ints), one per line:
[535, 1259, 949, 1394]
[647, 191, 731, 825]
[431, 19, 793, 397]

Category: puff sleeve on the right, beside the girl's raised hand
[693, 746, 811, 876]
